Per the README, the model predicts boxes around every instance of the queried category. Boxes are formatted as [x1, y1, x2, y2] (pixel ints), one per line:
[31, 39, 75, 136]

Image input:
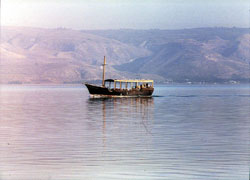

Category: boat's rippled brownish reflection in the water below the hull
[88, 97, 154, 148]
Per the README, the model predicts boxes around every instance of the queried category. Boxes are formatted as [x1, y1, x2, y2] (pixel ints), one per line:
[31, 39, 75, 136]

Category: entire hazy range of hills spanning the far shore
[0, 27, 250, 83]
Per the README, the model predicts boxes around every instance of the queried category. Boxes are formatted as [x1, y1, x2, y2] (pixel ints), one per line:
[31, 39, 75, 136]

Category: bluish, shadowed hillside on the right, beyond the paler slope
[86, 28, 250, 82]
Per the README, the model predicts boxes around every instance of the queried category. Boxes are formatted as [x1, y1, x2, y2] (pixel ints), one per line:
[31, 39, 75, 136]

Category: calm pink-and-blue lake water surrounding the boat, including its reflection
[0, 85, 250, 180]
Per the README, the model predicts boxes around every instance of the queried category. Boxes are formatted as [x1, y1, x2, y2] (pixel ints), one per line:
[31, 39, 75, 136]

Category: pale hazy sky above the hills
[1, 0, 250, 29]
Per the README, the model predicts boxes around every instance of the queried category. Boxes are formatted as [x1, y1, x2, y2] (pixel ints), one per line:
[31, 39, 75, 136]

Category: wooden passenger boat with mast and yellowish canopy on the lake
[85, 56, 154, 97]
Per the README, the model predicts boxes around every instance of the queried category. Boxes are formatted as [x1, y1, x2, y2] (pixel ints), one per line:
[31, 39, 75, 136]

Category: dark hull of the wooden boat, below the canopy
[85, 83, 154, 97]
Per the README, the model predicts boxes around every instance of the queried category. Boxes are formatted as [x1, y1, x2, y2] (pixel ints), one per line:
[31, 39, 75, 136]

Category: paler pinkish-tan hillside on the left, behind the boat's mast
[0, 27, 150, 83]
